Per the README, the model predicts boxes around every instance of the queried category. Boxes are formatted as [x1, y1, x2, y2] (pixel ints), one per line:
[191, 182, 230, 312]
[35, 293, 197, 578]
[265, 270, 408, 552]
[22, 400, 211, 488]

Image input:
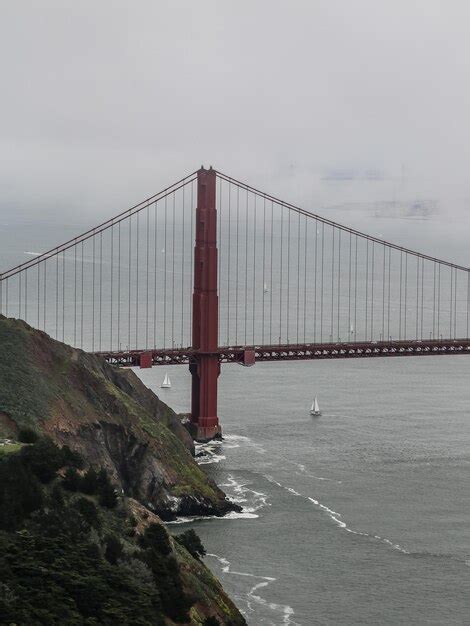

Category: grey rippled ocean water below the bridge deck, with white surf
[136, 356, 470, 626]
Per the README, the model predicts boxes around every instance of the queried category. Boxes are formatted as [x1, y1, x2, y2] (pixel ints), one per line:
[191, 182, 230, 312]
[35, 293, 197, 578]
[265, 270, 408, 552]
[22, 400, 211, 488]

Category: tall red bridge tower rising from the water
[189, 167, 221, 441]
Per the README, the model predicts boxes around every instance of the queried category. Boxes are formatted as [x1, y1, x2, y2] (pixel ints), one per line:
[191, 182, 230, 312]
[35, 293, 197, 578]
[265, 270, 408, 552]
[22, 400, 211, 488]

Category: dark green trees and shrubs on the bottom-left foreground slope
[0, 438, 206, 626]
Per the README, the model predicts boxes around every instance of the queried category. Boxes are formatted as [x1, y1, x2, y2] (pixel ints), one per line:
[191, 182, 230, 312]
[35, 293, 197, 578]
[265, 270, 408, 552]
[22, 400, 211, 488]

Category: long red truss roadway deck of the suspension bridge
[94, 339, 470, 367]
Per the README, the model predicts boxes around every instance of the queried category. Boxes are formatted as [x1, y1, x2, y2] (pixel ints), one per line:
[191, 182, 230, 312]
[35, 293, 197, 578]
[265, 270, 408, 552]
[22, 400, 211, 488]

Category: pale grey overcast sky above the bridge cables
[0, 0, 470, 221]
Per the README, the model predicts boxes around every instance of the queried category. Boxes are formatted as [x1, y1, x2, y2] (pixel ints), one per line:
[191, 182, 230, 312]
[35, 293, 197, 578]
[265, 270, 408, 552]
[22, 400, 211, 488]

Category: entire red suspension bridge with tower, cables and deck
[0, 167, 470, 441]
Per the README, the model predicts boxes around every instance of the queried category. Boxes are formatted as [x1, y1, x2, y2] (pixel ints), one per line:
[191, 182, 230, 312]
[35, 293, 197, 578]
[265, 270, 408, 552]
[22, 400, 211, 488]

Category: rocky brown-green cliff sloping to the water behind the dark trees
[0, 316, 235, 520]
